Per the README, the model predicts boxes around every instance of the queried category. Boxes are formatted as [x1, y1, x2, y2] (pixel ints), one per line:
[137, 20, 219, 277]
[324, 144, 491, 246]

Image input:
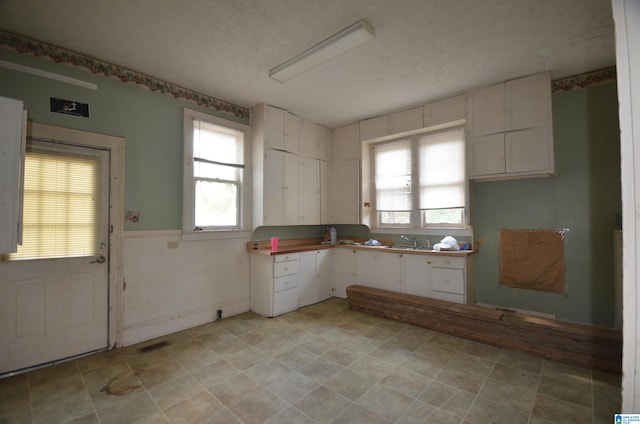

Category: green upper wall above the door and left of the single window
[0, 50, 247, 234]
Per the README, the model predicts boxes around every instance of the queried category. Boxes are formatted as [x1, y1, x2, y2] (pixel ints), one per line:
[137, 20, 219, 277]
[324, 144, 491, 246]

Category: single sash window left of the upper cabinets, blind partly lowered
[184, 109, 247, 232]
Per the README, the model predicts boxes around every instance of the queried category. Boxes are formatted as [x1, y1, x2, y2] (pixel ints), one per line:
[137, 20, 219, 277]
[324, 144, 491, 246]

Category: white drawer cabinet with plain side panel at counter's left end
[250, 253, 300, 317]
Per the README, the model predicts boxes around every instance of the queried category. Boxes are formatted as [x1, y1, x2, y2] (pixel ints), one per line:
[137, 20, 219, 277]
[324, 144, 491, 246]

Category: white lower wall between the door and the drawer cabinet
[122, 231, 251, 346]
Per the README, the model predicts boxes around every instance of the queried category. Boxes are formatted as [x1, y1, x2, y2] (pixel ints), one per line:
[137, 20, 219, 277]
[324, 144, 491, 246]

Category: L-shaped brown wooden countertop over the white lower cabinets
[247, 239, 477, 257]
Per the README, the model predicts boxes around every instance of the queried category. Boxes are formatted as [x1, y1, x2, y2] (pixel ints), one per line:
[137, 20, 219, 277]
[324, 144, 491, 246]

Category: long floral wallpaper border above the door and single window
[0, 29, 250, 121]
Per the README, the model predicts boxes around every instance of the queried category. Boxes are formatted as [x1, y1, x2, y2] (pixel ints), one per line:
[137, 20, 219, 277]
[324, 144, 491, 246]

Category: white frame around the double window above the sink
[363, 125, 471, 233]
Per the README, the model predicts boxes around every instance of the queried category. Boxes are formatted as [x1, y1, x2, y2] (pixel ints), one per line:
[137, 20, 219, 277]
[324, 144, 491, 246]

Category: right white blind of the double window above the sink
[419, 129, 466, 210]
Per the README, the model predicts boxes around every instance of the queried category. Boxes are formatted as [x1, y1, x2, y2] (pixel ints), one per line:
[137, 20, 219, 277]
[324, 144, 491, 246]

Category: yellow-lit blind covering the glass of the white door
[9, 151, 98, 259]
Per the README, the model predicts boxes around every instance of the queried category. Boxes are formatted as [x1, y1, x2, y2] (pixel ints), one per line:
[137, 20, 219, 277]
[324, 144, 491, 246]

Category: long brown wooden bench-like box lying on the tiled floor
[347, 285, 622, 374]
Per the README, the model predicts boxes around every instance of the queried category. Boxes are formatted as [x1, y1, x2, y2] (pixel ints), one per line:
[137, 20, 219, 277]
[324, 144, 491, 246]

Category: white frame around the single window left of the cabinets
[182, 108, 251, 240]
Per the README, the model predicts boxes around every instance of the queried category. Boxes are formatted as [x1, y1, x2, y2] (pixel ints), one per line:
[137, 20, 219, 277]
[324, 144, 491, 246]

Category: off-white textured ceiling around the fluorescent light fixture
[0, 0, 615, 128]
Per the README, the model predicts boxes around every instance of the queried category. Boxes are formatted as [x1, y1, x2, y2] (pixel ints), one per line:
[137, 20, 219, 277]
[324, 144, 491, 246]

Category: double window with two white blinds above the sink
[371, 129, 467, 228]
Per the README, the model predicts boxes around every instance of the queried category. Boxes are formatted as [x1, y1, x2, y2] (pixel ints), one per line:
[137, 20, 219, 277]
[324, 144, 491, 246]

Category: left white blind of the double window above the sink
[374, 140, 412, 212]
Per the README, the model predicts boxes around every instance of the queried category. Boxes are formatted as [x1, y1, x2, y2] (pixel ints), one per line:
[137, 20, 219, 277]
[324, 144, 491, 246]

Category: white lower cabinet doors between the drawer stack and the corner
[298, 250, 332, 307]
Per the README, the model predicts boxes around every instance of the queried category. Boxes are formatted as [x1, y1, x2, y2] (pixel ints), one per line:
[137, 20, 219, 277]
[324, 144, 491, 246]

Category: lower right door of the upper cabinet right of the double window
[505, 127, 553, 174]
